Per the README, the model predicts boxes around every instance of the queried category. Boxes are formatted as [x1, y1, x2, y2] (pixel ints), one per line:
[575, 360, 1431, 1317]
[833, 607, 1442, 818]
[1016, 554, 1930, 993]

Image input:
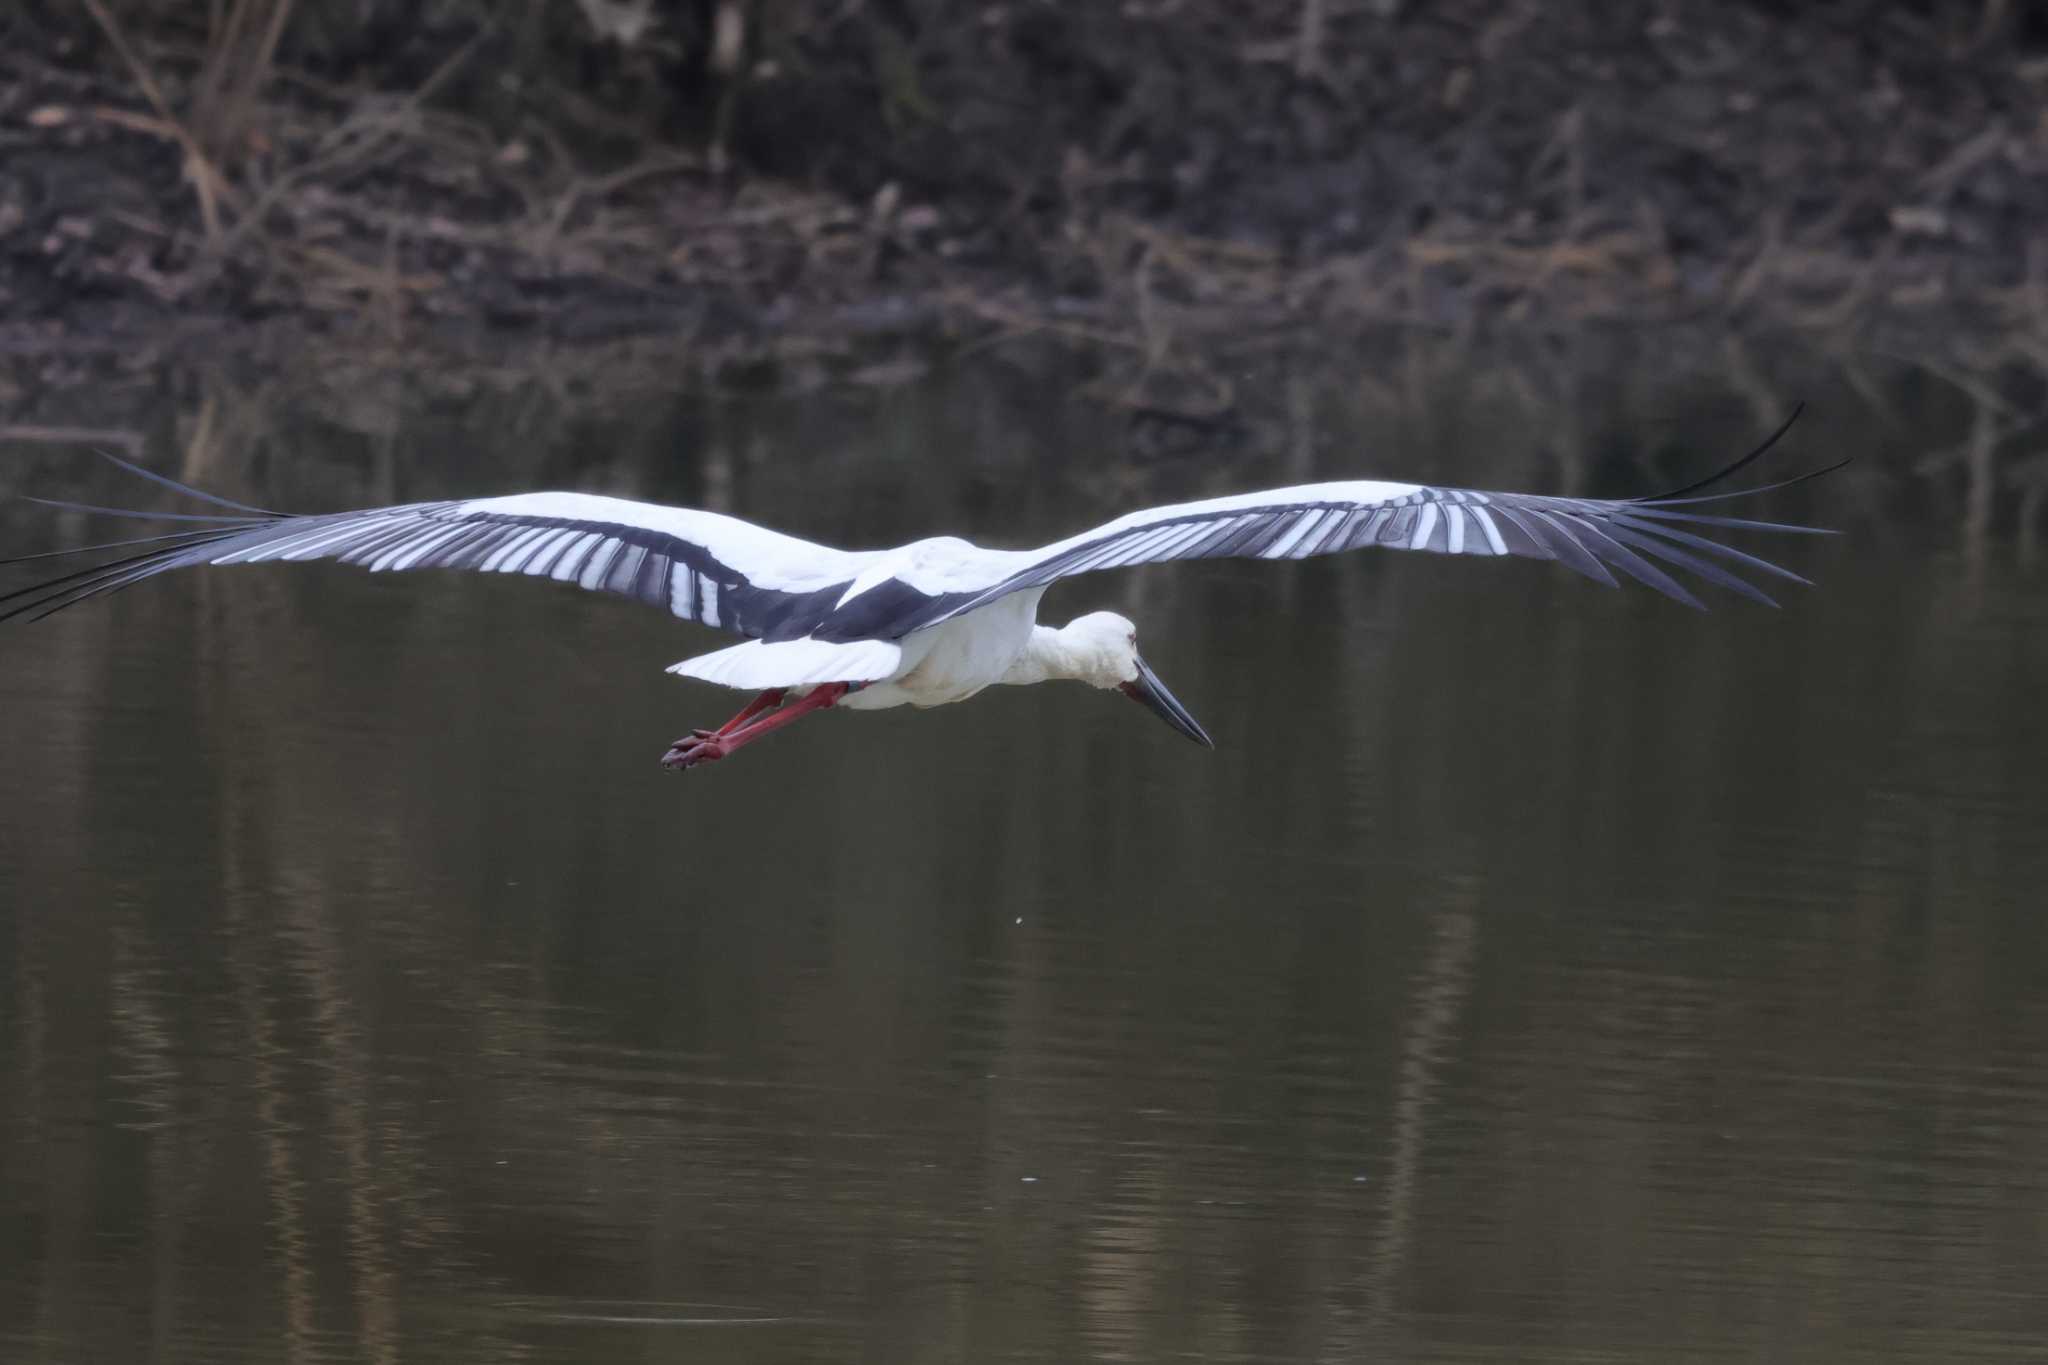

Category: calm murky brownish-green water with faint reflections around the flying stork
[0, 347, 2048, 1361]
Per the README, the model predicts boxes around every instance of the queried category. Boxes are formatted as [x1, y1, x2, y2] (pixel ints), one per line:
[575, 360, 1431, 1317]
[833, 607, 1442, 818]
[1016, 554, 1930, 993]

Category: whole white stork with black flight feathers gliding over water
[0, 409, 1847, 769]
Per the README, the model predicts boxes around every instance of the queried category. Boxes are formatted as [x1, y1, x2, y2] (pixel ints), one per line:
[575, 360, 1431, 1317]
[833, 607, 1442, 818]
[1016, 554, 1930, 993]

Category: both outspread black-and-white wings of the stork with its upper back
[0, 411, 1833, 643]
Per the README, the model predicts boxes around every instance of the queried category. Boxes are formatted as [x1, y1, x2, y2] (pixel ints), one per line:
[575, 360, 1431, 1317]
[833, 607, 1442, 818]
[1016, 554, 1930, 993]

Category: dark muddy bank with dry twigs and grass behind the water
[0, 0, 2048, 388]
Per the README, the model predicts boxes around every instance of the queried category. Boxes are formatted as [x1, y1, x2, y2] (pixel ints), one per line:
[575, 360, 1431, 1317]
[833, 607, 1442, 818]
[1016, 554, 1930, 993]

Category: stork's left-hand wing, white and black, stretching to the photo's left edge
[0, 478, 872, 636]
